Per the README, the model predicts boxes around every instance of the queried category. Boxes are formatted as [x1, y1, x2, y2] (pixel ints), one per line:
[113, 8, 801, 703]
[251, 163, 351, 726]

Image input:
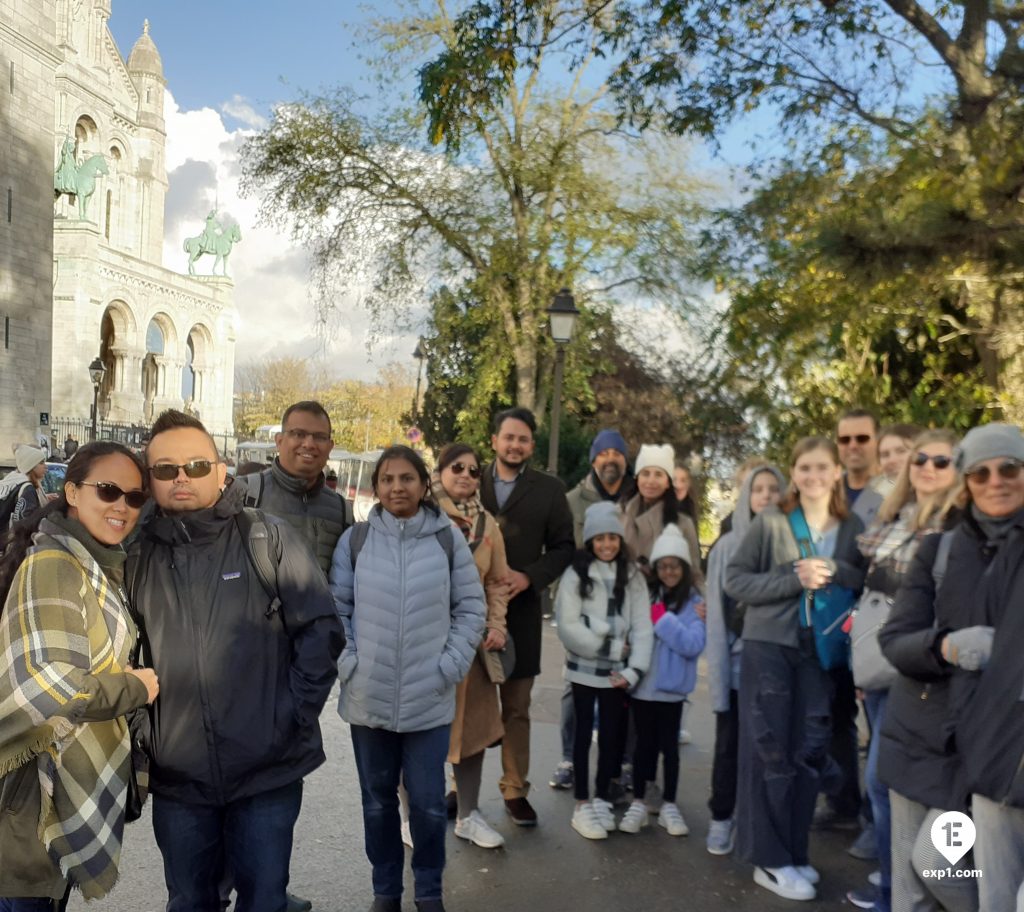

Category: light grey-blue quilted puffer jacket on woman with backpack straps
[330, 505, 486, 732]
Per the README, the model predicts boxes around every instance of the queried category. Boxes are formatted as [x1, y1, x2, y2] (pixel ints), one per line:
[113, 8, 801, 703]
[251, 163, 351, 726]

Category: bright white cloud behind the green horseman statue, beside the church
[164, 92, 416, 380]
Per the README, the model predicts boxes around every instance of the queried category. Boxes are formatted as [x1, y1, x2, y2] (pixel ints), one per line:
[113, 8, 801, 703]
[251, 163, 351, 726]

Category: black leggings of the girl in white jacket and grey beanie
[572, 682, 629, 801]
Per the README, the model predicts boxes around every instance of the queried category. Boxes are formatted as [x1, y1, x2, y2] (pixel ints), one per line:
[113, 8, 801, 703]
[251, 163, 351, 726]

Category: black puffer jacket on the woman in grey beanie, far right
[879, 514, 1024, 809]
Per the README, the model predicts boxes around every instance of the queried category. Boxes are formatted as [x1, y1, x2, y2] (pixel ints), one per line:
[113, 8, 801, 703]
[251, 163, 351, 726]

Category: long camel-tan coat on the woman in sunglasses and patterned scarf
[447, 513, 509, 764]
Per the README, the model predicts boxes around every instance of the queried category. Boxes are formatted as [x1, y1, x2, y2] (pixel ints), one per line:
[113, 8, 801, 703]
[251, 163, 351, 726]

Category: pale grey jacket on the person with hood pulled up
[705, 464, 785, 712]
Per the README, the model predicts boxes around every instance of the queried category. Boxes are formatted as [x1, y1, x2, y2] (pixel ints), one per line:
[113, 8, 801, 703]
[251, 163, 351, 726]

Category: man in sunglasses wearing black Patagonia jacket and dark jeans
[128, 410, 344, 912]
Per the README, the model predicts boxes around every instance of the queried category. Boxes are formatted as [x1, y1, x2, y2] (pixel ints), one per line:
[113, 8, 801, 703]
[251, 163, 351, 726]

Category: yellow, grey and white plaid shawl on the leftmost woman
[0, 523, 135, 899]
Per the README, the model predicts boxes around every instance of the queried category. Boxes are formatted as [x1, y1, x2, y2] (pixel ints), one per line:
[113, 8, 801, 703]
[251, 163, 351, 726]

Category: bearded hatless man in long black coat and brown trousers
[480, 408, 574, 826]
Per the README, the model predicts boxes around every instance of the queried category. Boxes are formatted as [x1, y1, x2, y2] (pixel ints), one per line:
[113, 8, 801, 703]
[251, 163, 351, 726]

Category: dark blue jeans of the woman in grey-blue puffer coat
[352, 725, 451, 900]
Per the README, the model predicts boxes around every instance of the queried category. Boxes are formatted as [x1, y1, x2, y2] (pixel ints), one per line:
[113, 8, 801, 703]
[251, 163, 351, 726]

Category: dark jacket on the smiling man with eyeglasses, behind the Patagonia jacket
[234, 457, 352, 575]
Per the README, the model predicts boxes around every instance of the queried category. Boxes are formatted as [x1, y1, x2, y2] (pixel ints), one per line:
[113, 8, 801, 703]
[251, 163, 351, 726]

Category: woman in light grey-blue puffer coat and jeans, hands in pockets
[330, 446, 485, 912]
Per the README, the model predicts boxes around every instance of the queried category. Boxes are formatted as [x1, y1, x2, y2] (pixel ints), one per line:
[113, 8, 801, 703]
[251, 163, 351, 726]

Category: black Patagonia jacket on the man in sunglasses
[129, 486, 344, 805]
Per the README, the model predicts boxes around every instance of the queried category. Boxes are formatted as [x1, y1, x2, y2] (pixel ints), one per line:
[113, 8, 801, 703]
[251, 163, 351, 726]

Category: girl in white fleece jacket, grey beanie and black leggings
[555, 502, 653, 839]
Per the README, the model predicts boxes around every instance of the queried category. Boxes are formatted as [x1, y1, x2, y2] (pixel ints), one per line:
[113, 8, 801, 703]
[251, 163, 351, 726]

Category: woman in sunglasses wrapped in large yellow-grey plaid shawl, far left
[0, 442, 159, 912]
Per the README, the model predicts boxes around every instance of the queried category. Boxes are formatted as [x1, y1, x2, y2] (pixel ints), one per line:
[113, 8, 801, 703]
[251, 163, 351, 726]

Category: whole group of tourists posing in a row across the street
[0, 401, 1024, 912]
